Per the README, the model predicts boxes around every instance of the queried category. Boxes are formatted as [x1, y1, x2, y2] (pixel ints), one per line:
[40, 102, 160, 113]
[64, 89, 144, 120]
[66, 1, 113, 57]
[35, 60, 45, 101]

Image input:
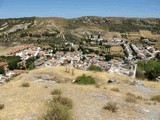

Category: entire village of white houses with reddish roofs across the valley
[0, 35, 160, 83]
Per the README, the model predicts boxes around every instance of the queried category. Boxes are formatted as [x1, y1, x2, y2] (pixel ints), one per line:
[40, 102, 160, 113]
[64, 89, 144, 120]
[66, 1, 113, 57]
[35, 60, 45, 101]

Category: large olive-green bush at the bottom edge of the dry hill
[43, 96, 73, 120]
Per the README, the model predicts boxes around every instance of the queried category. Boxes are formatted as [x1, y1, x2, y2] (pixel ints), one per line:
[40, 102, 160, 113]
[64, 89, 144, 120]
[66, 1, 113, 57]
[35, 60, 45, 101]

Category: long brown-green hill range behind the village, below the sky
[0, 16, 160, 45]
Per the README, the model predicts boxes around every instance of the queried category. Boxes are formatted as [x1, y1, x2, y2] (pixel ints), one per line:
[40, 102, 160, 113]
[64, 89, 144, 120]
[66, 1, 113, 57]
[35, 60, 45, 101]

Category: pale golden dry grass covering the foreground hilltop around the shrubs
[0, 67, 159, 120]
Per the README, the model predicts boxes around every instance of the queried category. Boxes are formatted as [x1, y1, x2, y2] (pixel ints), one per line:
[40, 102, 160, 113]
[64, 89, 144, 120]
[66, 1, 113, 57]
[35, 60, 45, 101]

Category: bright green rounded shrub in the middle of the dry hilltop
[75, 74, 96, 85]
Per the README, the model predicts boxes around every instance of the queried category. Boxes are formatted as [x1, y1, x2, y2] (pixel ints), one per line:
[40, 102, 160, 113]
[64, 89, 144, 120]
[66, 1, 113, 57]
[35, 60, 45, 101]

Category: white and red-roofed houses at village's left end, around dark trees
[0, 45, 44, 83]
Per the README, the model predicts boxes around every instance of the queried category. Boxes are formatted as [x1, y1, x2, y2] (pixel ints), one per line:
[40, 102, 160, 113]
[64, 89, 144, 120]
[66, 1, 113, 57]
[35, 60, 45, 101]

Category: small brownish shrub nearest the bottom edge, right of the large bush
[103, 102, 118, 112]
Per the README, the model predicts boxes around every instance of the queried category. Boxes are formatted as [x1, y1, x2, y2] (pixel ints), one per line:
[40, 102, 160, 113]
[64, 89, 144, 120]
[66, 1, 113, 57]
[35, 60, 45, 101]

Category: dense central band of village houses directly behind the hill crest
[41, 52, 136, 77]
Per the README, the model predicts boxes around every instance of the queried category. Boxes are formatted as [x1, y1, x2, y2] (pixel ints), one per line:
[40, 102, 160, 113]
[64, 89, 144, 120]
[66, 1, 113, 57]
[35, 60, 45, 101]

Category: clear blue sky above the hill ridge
[0, 0, 160, 18]
